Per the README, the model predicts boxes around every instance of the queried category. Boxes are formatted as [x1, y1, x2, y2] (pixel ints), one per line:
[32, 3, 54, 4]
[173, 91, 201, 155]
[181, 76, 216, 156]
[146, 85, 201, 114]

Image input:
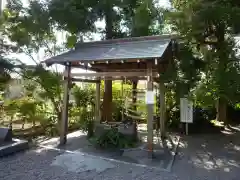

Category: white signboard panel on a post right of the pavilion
[180, 98, 193, 123]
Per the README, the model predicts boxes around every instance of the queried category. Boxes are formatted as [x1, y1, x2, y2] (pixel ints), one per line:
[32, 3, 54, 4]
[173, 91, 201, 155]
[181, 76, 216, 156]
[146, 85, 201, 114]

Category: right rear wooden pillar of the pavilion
[159, 80, 166, 138]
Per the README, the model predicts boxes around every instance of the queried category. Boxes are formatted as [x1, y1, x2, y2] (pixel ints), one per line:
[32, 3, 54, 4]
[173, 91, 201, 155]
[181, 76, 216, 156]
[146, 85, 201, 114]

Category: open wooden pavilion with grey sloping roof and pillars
[44, 35, 175, 155]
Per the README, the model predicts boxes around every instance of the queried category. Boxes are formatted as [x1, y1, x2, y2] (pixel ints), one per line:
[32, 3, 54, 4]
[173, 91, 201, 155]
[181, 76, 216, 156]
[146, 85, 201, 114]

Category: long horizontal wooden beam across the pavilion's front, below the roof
[63, 71, 158, 77]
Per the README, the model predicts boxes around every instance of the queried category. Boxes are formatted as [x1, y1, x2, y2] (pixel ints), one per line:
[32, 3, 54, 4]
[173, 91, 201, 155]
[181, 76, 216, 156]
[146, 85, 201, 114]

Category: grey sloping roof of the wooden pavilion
[44, 36, 174, 64]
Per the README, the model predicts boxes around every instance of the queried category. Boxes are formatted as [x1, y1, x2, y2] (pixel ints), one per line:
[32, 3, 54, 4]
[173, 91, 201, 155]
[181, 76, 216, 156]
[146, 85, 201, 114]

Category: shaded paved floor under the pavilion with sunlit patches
[40, 124, 178, 171]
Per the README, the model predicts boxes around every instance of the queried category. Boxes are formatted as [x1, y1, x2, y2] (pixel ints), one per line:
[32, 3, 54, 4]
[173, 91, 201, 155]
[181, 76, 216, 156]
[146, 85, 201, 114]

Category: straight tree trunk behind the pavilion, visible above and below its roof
[101, 2, 113, 122]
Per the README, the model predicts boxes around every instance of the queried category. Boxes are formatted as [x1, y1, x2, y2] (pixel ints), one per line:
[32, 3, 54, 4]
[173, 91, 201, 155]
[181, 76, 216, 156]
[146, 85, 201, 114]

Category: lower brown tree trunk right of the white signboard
[216, 98, 228, 125]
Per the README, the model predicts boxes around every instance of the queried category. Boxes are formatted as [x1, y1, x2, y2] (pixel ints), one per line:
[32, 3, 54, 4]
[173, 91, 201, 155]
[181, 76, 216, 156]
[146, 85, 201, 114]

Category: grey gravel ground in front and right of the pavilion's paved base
[0, 126, 240, 180]
